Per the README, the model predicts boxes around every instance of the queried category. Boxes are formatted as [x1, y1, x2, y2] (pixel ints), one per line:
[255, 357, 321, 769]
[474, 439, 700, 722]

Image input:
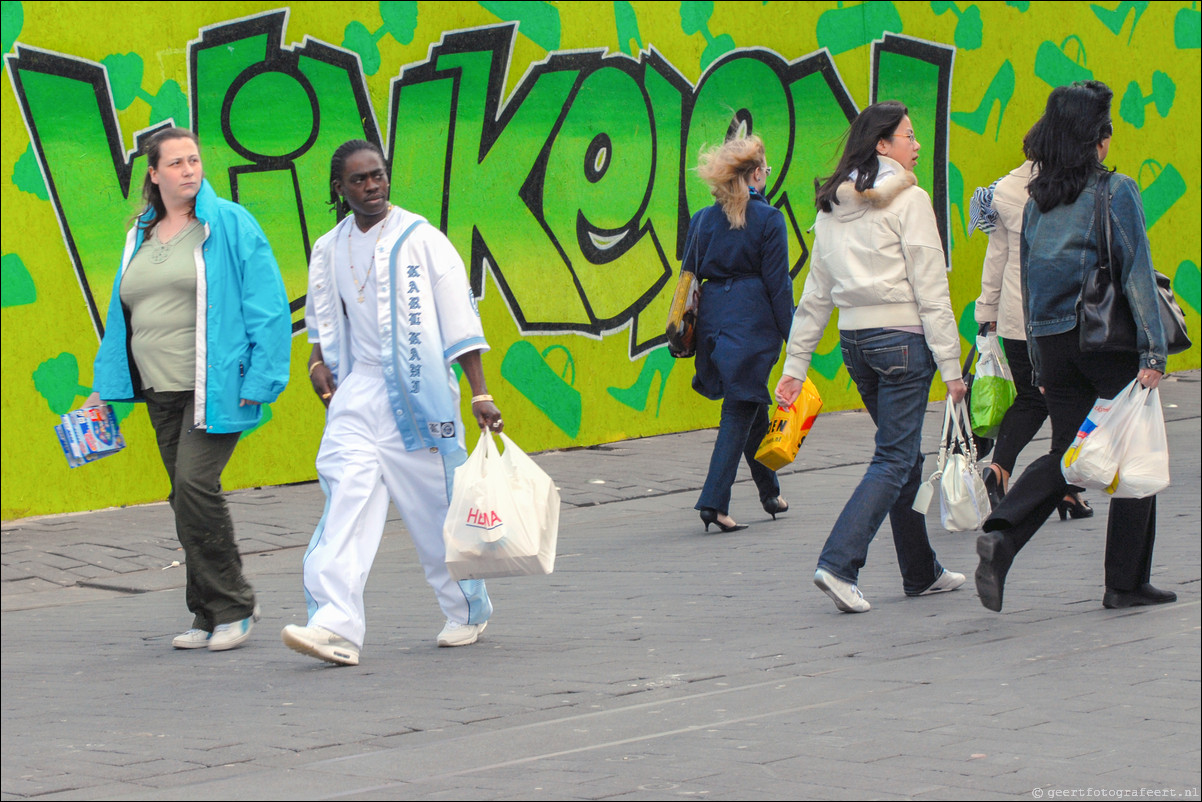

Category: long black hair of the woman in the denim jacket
[1024, 81, 1114, 213]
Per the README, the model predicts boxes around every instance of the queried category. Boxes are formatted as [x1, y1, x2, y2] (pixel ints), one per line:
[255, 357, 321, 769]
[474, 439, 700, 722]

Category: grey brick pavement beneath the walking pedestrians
[0, 372, 1202, 800]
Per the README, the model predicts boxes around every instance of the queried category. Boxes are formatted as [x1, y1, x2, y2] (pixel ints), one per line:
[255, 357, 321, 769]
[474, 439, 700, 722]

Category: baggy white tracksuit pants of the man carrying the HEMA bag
[304, 368, 493, 648]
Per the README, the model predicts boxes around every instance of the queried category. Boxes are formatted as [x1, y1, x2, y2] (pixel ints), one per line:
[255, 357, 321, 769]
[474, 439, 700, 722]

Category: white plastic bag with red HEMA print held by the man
[442, 430, 559, 580]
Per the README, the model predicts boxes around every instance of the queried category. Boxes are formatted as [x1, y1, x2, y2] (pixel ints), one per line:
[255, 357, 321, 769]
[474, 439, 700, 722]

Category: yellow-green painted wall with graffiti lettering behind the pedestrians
[0, 0, 1202, 519]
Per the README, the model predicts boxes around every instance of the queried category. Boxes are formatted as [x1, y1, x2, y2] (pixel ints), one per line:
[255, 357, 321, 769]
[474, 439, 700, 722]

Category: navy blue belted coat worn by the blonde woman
[680, 191, 793, 404]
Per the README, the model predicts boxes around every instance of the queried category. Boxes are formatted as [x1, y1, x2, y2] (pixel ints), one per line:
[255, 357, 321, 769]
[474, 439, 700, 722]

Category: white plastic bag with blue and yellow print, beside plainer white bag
[1060, 380, 1144, 498]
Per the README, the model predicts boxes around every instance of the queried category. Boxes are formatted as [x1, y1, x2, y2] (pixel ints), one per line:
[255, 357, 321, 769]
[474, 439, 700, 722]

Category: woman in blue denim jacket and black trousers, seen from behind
[976, 81, 1177, 611]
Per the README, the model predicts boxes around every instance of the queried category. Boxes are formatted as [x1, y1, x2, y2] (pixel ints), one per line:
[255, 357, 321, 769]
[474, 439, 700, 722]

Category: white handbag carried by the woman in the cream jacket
[914, 399, 990, 531]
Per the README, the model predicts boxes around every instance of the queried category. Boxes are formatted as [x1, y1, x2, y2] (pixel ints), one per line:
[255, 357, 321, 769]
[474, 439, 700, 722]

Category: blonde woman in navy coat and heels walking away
[682, 136, 793, 531]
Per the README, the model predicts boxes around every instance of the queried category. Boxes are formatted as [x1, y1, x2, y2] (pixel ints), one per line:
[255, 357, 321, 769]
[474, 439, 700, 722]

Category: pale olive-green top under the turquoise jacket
[121, 220, 204, 392]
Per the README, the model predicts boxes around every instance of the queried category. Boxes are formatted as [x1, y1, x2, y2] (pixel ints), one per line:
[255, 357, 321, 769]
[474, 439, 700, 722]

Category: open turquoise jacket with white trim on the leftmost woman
[93, 179, 292, 433]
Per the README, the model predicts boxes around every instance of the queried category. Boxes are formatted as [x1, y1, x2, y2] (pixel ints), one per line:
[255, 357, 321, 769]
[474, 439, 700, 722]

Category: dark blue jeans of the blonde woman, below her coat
[694, 398, 780, 515]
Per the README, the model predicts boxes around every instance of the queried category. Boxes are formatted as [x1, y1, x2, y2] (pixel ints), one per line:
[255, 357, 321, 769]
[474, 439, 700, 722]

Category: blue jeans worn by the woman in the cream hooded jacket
[819, 328, 944, 595]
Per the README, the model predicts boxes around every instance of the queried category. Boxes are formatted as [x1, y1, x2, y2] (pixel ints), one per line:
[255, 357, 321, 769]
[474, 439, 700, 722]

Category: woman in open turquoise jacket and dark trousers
[89, 127, 292, 650]
